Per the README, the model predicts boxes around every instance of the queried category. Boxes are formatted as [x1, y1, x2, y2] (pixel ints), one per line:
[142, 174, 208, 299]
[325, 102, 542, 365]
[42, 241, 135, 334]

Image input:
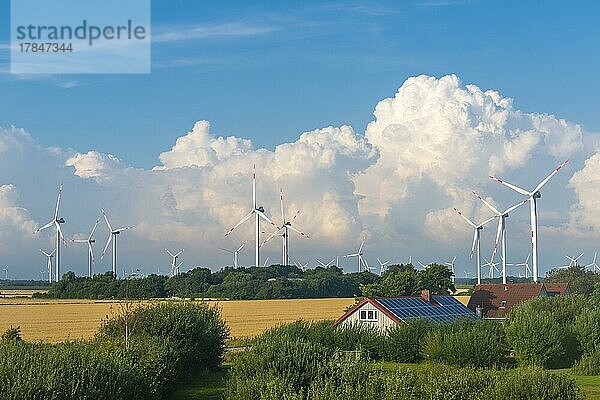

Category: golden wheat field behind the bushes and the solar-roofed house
[0, 298, 354, 342]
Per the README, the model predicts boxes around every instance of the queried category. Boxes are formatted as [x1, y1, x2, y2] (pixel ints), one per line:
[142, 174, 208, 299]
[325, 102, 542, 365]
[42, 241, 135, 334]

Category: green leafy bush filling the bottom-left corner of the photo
[0, 340, 152, 400]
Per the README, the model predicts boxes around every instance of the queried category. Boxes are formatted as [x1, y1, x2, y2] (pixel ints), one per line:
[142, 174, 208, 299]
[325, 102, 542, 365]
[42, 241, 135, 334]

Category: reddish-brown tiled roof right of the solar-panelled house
[467, 283, 567, 318]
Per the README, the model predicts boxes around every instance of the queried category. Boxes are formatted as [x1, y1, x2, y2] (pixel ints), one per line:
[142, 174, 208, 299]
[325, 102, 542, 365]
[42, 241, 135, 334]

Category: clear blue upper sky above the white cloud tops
[0, 0, 600, 167]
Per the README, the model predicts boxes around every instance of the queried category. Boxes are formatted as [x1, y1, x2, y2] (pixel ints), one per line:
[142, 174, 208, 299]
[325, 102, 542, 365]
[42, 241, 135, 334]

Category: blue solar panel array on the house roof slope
[377, 295, 477, 322]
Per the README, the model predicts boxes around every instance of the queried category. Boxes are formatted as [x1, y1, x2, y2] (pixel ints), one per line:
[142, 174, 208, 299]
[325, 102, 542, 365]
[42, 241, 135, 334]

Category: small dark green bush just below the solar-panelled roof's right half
[384, 318, 435, 363]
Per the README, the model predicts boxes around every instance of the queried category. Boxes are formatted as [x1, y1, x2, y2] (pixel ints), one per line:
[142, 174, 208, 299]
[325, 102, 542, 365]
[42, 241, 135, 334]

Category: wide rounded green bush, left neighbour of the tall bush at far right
[423, 319, 508, 368]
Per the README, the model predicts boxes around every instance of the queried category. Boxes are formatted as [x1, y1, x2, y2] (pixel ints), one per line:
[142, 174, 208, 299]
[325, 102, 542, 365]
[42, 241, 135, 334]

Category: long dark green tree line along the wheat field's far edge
[35, 264, 455, 300]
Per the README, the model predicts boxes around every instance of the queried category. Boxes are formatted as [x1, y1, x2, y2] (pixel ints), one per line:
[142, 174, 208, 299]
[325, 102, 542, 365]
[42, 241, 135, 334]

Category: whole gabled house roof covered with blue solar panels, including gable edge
[336, 295, 477, 324]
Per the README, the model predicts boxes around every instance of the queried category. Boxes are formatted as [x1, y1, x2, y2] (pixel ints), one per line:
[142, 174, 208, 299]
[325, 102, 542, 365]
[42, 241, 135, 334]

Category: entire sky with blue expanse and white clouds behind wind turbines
[0, 0, 600, 277]
